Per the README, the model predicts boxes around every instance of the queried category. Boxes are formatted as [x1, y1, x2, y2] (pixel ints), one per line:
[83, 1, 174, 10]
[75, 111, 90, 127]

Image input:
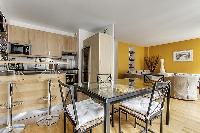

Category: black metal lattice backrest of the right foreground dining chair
[147, 81, 171, 117]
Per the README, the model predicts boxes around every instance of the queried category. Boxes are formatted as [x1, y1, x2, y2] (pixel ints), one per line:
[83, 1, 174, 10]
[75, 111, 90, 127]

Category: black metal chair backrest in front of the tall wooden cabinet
[97, 74, 112, 87]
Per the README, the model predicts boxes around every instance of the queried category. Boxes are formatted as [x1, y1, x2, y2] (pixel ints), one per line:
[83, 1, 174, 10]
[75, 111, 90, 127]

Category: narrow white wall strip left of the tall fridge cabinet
[77, 29, 94, 84]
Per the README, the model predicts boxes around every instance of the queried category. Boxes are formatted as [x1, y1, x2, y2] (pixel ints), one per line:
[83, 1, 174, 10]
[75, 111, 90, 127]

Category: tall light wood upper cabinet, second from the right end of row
[47, 33, 63, 57]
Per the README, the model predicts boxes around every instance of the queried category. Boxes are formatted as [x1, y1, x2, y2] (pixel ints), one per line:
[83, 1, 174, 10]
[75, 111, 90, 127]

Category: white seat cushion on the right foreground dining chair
[121, 97, 161, 119]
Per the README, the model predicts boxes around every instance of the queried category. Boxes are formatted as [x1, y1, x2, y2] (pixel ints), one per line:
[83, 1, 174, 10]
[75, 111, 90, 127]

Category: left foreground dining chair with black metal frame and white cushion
[58, 80, 104, 133]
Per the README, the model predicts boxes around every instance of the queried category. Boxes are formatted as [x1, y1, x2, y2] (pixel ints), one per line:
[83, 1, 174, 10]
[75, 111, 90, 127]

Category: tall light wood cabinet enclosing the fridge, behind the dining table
[83, 33, 113, 82]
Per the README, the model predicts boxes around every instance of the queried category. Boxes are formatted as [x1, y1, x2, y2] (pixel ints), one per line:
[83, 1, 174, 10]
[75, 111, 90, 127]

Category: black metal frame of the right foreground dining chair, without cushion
[119, 81, 171, 133]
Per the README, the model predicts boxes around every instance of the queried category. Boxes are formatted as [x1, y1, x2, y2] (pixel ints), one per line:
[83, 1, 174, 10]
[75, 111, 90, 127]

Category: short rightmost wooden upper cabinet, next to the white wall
[62, 36, 77, 53]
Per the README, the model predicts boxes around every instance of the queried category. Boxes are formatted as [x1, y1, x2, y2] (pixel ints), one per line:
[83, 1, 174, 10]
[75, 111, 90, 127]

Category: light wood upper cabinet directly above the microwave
[8, 25, 30, 44]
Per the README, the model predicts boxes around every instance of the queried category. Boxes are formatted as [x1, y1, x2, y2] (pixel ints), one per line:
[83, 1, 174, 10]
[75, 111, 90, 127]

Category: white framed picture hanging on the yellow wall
[173, 50, 193, 61]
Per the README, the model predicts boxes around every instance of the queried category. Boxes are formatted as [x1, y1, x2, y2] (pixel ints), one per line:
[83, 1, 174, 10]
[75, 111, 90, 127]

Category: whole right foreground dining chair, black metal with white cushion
[119, 81, 171, 133]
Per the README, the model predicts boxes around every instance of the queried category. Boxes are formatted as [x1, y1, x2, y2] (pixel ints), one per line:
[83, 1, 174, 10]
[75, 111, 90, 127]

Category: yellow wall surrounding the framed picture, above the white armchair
[148, 38, 200, 73]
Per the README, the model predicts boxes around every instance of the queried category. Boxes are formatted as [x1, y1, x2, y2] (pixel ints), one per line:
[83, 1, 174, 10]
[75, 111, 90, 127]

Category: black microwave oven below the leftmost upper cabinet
[10, 43, 31, 55]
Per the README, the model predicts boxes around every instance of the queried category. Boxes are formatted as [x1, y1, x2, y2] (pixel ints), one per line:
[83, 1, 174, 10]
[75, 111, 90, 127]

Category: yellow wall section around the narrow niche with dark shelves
[118, 42, 145, 78]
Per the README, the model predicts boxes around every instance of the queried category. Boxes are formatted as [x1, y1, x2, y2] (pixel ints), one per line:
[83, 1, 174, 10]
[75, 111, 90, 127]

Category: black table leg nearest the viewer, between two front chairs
[104, 102, 110, 133]
